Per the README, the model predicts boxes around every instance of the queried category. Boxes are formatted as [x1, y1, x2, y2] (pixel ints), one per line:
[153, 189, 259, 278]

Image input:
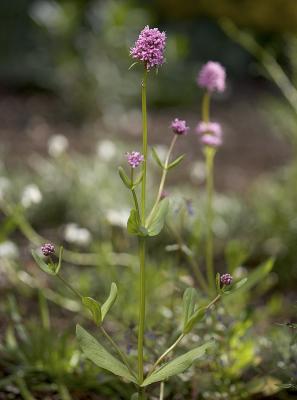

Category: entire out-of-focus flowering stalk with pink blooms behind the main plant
[197, 61, 226, 292]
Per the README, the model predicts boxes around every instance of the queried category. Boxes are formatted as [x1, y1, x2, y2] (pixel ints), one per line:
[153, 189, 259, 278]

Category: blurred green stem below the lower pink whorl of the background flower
[205, 147, 215, 291]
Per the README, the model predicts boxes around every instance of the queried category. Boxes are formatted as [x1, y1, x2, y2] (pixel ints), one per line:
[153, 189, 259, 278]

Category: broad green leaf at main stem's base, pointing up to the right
[141, 341, 214, 386]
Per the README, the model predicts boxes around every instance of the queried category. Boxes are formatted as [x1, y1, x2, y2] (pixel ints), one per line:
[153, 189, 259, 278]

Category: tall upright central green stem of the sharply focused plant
[137, 67, 148, 394]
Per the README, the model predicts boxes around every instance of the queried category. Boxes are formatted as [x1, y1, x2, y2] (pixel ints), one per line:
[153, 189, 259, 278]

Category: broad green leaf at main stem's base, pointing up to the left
[76, 325, 137, 383]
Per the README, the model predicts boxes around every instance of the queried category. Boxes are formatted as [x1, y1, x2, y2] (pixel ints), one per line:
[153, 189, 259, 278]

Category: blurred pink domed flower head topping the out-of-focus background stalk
[197, 61, 226, 92]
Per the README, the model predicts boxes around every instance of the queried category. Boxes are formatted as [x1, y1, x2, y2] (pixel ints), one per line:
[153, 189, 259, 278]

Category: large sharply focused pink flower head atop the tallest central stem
[130, 26, 166, 70]
